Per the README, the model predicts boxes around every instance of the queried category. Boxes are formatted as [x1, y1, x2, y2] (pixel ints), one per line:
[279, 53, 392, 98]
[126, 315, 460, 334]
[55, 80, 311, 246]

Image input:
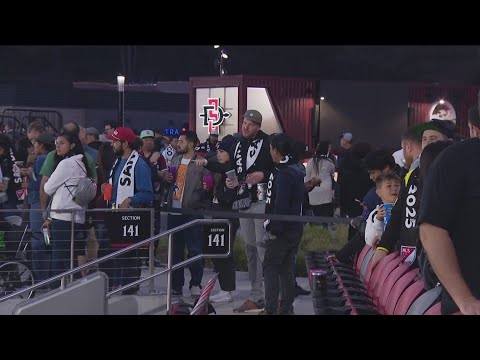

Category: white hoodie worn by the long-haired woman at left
[44, 155, 87, 224]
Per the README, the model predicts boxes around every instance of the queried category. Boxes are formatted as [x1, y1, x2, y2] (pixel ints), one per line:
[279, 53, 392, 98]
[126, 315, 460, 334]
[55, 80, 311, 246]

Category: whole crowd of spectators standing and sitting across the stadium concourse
[0, 103, 480, 315]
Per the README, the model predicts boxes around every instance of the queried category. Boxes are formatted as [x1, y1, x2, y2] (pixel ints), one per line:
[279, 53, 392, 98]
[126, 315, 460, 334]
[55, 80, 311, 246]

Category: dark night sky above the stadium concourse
[0, 45, 480, 84]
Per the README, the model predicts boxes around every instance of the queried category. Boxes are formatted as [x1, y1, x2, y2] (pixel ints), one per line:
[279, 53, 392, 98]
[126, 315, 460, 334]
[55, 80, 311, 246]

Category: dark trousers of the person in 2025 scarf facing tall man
[263, 233, 302, 314]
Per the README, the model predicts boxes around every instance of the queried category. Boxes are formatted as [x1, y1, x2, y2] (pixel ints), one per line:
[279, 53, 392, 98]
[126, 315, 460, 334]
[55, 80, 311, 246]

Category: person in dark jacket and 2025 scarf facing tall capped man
[261, 134, 305, 315]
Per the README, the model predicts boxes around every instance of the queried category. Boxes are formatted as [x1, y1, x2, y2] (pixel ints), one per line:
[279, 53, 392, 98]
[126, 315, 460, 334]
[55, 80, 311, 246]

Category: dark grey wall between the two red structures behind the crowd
[319, 81, 408, 149]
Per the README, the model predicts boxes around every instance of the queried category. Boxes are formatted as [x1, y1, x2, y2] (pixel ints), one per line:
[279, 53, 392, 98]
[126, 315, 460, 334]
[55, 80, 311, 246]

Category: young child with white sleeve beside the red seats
[365, 173, 400, 247]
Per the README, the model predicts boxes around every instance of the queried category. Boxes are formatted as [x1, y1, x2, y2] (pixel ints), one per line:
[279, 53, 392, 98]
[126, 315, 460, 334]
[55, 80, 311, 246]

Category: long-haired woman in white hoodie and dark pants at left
[42, 132, 92, 288]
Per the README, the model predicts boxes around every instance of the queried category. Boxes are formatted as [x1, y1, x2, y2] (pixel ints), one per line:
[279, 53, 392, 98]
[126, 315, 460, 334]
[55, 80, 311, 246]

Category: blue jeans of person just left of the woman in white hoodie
[30, 202, 50, 283]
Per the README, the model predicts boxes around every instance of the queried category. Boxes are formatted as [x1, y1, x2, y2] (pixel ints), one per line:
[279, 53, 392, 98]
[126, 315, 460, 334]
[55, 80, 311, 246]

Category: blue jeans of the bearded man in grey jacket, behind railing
[168, 214, 203, 291]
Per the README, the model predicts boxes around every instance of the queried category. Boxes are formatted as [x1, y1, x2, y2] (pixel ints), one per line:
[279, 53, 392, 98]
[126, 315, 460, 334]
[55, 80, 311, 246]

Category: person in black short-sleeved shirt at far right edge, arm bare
[419, 106, 480, 315]
